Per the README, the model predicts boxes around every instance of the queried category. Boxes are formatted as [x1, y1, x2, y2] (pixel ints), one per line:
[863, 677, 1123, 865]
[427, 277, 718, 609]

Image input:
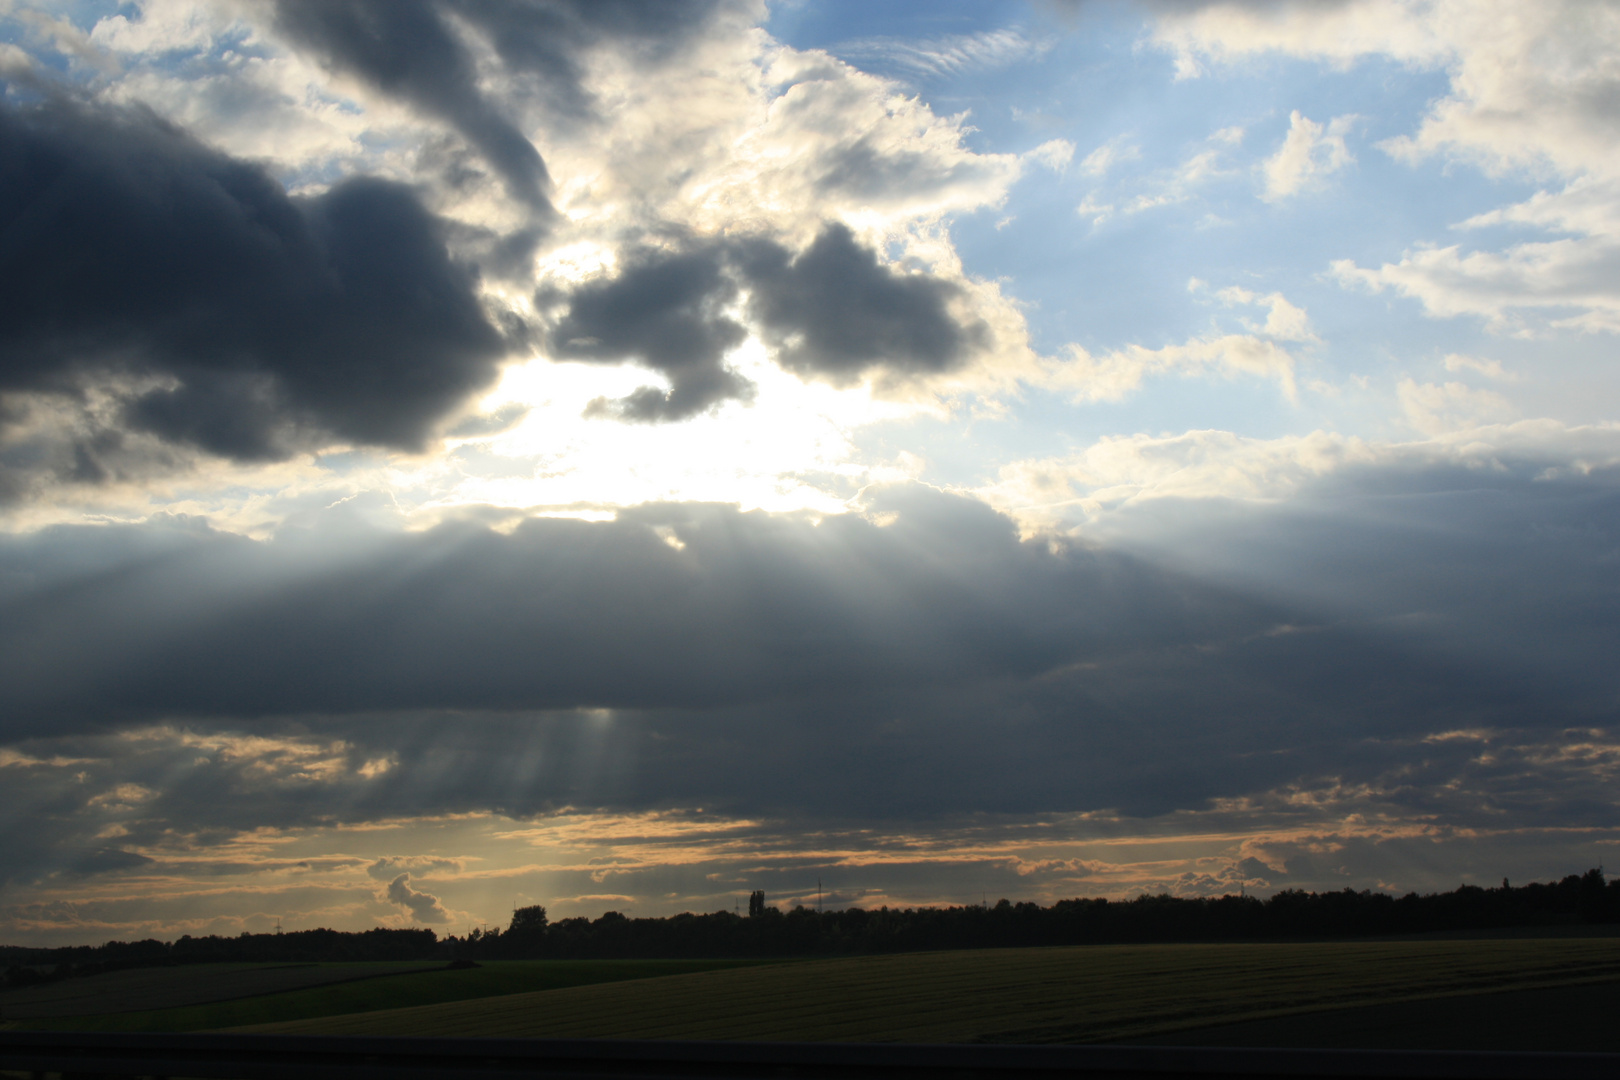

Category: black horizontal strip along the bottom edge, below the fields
[0, 1031, 1620, 1080]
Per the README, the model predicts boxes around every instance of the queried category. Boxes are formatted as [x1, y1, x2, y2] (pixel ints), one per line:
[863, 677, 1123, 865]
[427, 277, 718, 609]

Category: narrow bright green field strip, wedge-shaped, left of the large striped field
[0, 960, 782, 1031]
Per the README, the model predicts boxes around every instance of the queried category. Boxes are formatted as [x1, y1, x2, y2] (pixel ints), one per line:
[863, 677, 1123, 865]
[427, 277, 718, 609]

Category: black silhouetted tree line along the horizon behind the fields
[0, 870, 1620, 984]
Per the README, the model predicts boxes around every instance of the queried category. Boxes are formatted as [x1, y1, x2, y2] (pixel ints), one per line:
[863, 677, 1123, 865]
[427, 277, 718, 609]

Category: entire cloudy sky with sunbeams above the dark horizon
[0, 0, 1620, 944]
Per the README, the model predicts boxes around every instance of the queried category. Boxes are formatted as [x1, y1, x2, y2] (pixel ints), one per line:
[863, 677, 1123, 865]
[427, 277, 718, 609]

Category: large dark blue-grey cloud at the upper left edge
[0, 100, 504, 458]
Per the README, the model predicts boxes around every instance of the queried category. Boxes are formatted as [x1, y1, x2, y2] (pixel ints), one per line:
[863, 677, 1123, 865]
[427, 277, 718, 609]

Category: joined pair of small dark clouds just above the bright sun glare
[550, 223, 990, 421]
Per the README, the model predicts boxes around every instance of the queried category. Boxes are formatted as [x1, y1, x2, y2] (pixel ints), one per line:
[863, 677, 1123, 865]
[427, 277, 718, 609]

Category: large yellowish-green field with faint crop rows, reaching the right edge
[243, 939, 1620, 1043]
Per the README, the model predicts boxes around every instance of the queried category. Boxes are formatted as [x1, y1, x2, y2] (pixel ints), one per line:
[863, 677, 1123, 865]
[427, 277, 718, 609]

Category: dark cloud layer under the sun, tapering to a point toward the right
[0, 489, 1268, 733]
